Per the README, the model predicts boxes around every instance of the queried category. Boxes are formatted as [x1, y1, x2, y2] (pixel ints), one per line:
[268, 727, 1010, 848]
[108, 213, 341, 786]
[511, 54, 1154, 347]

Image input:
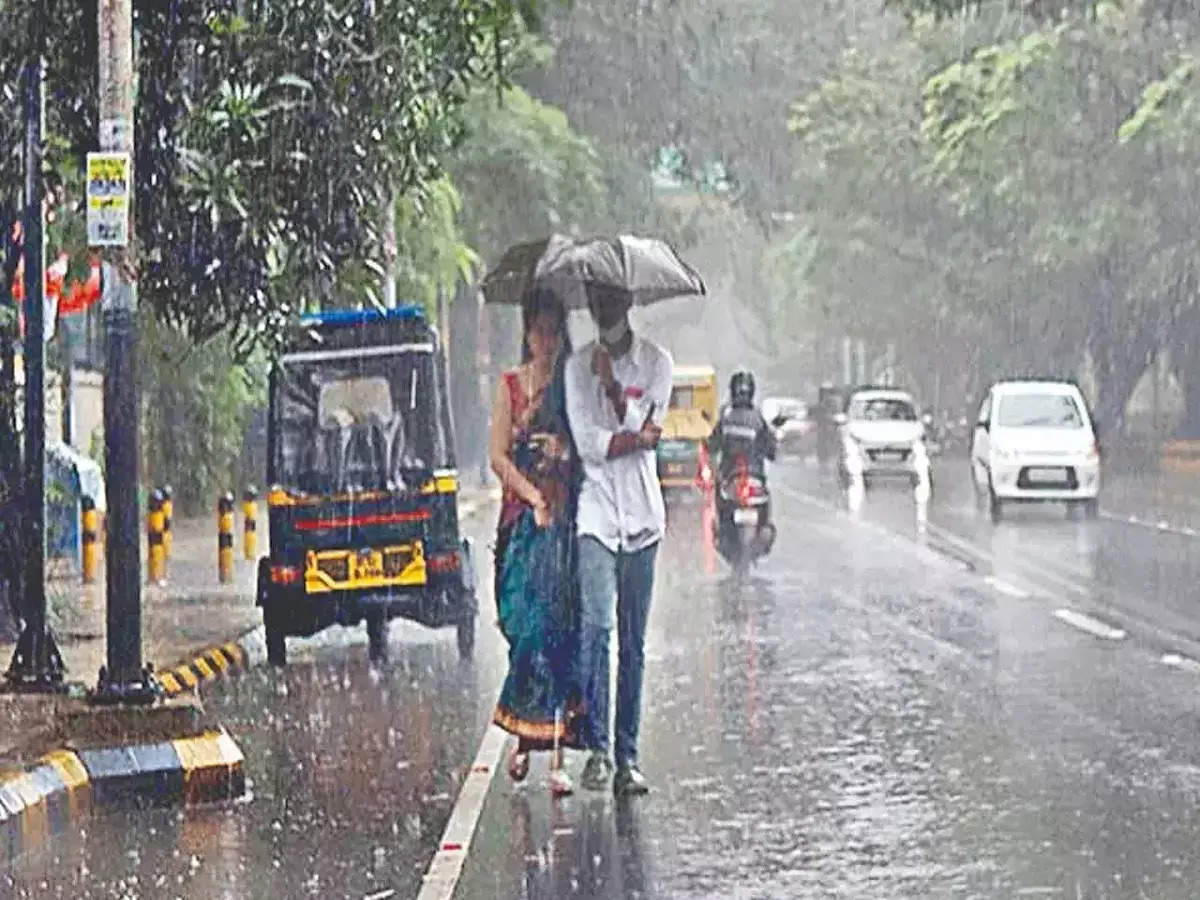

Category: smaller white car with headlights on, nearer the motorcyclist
[839, 388, 931, 487]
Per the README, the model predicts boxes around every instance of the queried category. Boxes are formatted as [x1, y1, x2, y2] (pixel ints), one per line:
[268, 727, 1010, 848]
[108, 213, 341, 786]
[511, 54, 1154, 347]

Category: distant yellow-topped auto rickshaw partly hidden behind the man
[658, 366, 718, 491]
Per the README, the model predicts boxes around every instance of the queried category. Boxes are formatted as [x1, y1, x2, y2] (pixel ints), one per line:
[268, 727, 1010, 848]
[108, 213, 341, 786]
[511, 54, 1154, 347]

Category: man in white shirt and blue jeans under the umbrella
[565, 289, 671, 794]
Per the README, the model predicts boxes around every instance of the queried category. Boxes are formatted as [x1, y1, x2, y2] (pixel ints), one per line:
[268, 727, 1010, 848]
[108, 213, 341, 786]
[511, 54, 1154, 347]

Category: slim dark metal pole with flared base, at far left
[7, 0, 64, 691]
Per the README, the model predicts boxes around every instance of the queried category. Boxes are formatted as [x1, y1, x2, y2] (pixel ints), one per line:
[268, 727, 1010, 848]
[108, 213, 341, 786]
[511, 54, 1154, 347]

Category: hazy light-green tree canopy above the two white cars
[781, 0, 1200, 421]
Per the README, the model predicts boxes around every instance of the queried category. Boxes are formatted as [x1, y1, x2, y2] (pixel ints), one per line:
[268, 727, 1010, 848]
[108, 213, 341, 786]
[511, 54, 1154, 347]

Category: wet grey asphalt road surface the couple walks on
[11, 462, 1200, 899]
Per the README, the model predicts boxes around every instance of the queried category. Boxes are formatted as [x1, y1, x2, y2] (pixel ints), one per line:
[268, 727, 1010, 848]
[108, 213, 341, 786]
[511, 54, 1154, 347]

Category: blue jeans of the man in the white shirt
[578, 535, 659, 766]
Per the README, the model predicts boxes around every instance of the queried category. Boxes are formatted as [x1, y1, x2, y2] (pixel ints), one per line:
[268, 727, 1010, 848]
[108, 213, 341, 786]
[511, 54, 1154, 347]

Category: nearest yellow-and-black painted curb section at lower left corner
[0, 728, 246, 864]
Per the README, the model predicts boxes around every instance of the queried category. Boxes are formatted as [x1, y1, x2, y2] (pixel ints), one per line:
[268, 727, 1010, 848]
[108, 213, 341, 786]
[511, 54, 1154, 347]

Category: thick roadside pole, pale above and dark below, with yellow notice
[89, 0, 156, 702]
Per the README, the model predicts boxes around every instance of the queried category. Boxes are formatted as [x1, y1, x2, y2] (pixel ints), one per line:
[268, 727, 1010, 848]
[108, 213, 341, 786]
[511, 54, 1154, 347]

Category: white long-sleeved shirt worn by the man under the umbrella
[565, 335, 672, 553]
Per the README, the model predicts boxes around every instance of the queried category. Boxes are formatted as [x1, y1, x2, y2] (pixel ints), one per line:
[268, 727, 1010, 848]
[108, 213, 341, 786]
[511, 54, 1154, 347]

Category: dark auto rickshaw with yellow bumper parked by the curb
[257, 307, 476, 665]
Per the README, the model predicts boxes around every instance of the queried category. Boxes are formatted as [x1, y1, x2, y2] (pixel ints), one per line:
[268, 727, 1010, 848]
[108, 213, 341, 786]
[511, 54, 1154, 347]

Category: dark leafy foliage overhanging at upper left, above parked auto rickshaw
[0, 0, 540, 356]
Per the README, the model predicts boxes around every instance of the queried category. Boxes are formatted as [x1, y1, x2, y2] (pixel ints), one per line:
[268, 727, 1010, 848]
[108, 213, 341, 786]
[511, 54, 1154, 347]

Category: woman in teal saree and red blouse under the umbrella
[488, 289, 577, 796]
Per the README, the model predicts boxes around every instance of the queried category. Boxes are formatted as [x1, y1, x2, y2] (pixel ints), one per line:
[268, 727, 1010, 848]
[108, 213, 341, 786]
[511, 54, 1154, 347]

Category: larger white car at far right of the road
[971, 382, 1100, 520]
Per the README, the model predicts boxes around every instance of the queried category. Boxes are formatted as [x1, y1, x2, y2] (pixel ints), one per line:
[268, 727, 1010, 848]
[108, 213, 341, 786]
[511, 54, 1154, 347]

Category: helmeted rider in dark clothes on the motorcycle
[708, 368, 776, 552]
